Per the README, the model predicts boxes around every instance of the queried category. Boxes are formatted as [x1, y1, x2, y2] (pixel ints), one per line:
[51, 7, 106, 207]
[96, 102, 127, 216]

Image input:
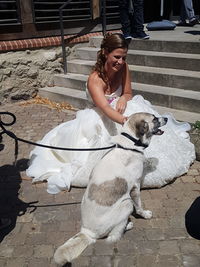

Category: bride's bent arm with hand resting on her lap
[116, 63, 132, 114]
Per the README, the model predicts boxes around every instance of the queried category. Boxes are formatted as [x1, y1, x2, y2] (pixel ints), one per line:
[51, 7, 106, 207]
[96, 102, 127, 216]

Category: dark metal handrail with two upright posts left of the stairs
[59, 0, 106, 74]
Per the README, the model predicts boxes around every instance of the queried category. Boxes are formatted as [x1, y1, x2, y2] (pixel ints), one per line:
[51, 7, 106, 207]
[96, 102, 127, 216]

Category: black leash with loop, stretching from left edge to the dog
[0, 112, 116, 163]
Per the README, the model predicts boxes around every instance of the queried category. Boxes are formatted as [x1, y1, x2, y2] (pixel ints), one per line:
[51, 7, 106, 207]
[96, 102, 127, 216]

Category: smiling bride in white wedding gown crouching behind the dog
[27, 33, 195, 194]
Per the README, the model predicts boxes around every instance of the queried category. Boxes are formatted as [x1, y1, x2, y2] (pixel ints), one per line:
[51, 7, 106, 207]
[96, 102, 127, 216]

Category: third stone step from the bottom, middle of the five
[68, 59, 200, 91]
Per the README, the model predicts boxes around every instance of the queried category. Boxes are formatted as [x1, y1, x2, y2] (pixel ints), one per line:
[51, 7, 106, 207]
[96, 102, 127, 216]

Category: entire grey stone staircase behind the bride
[39, 36, 200, 122]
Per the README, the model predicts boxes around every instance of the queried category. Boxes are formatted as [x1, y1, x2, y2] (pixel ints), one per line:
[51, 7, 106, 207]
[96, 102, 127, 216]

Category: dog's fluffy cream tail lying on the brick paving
[54, 231, 96, 266]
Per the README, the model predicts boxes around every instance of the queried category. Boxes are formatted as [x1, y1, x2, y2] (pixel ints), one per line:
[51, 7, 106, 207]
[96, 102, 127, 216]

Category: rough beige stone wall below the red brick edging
[0, 46, 83, 103]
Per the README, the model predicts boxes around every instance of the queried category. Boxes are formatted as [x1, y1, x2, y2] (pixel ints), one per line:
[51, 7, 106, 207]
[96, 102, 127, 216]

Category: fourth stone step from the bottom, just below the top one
[76, 47, 200, 71]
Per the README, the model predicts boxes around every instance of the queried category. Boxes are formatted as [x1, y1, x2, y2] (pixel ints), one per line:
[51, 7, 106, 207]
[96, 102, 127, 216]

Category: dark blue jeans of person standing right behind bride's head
[119, 0, 144, 35]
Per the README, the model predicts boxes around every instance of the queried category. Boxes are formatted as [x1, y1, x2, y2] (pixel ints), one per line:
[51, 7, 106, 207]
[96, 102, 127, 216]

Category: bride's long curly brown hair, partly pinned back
[93, 33, 128, 83]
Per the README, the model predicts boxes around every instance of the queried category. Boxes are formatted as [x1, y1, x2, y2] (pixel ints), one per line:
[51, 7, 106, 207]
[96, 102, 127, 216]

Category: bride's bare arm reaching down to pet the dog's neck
[87, 72, 126, 124]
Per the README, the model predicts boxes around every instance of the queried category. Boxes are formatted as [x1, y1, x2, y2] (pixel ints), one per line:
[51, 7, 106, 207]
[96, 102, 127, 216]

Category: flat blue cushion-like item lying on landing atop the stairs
[146, 19, 176, 31]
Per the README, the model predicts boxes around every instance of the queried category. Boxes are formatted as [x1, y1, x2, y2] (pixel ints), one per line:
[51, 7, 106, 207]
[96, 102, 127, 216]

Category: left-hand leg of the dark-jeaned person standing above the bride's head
[119, 0, 131, 38]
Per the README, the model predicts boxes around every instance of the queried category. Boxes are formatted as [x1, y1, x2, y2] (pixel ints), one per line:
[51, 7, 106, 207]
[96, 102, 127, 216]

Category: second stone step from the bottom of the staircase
[52, 73, 200, 113]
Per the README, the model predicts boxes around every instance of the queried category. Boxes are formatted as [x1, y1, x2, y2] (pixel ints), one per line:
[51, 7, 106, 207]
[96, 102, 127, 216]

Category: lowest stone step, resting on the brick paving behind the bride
[39, 86, 200, 123]
